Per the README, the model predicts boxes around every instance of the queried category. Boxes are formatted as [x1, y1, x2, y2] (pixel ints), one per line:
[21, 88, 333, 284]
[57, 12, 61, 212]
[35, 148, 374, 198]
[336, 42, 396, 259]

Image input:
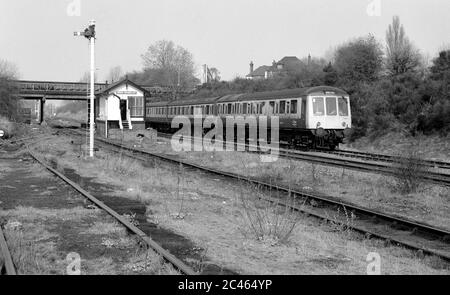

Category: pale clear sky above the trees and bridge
[0, 0, 450, 81]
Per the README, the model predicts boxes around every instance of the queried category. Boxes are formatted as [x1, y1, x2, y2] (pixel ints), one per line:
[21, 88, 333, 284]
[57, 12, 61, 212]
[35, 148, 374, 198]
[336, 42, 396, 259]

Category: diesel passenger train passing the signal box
[145, 86, 351, 149]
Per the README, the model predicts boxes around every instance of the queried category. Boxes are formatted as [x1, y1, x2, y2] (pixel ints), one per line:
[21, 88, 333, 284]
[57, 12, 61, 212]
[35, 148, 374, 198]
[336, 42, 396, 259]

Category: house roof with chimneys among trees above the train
[246, 56, 311, 80]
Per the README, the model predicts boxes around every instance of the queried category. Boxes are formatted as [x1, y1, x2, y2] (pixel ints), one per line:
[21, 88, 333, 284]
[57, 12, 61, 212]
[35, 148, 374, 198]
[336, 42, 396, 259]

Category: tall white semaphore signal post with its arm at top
[74, 20, 95, 157]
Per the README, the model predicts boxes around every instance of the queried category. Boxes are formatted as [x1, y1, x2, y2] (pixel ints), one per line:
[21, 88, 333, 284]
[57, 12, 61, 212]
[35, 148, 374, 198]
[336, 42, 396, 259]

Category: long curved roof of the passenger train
[149, 86, 348, 106]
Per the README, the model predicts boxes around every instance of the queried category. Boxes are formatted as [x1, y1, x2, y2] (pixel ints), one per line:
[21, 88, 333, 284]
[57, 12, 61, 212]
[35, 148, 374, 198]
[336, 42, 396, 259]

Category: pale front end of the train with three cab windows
[306, 92, 351, 149]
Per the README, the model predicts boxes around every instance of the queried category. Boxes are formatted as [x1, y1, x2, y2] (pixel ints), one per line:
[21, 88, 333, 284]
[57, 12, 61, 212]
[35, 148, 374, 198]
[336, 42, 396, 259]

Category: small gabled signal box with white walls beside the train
[94, 77, 150, 137]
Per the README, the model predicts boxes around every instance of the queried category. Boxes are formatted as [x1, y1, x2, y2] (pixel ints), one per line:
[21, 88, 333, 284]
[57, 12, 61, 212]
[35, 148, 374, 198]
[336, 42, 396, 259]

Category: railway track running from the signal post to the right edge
[63, 132, 450, 262]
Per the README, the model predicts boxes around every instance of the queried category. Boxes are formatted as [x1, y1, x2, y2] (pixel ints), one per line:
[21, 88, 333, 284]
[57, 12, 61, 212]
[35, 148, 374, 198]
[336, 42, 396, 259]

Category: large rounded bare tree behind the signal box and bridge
[142, 40, 195, 96]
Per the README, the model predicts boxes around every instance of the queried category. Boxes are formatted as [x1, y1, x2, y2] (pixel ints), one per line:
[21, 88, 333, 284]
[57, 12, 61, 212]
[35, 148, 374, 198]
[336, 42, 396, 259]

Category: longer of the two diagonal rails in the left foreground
[24, 148, 197, 275]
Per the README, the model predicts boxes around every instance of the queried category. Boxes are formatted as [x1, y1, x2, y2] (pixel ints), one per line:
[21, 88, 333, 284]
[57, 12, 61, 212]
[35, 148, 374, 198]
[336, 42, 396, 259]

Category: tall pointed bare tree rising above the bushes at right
[386, 16, 421, 75]
